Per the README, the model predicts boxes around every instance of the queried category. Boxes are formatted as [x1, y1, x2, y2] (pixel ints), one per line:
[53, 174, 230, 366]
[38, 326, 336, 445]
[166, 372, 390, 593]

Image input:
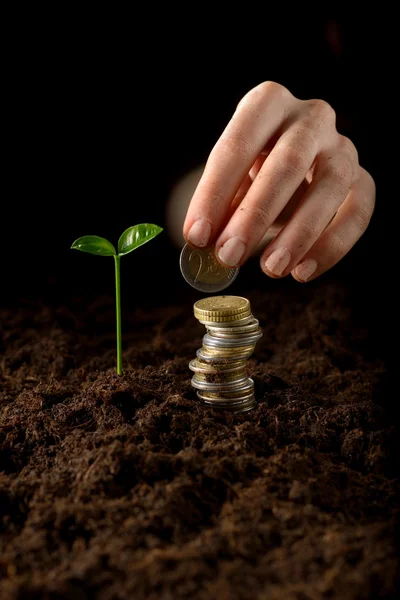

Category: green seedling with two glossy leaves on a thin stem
[71, 223, 162, 375]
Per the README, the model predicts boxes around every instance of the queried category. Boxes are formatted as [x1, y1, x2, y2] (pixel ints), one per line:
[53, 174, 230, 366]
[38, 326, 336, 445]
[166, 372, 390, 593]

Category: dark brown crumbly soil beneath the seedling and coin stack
[0, 280, 399, 600]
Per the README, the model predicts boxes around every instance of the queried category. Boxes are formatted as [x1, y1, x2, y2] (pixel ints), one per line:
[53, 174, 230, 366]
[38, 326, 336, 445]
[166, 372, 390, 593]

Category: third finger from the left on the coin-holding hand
[262, 136, 359, 277]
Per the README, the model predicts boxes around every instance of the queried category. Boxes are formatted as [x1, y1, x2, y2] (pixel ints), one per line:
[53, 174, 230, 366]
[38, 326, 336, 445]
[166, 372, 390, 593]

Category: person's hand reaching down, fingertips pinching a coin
[183, 82, 375, 282]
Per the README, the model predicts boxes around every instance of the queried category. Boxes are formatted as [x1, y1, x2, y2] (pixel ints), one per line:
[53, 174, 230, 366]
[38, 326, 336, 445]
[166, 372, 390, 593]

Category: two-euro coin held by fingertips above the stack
[179, 244, 239, 293]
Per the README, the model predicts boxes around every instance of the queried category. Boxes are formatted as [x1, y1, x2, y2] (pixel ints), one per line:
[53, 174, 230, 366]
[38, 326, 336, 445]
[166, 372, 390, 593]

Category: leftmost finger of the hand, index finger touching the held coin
[183, 82, 295, 246]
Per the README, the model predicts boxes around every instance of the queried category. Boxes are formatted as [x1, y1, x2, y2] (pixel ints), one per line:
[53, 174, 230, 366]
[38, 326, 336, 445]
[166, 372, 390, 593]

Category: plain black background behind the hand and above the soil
[1, 5, 391, 304]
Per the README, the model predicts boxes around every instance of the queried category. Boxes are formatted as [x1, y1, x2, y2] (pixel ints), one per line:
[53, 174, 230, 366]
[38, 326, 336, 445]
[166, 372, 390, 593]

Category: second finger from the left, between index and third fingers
[216, 101, 337, 267]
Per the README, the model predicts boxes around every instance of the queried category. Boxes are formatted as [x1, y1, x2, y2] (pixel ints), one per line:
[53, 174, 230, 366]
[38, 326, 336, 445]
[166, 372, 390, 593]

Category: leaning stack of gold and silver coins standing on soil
[189, 296, 262, 412]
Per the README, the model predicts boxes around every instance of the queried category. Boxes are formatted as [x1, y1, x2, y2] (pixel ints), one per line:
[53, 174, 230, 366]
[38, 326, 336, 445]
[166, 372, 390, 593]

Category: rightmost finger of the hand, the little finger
[292, 167, 375, 282]
